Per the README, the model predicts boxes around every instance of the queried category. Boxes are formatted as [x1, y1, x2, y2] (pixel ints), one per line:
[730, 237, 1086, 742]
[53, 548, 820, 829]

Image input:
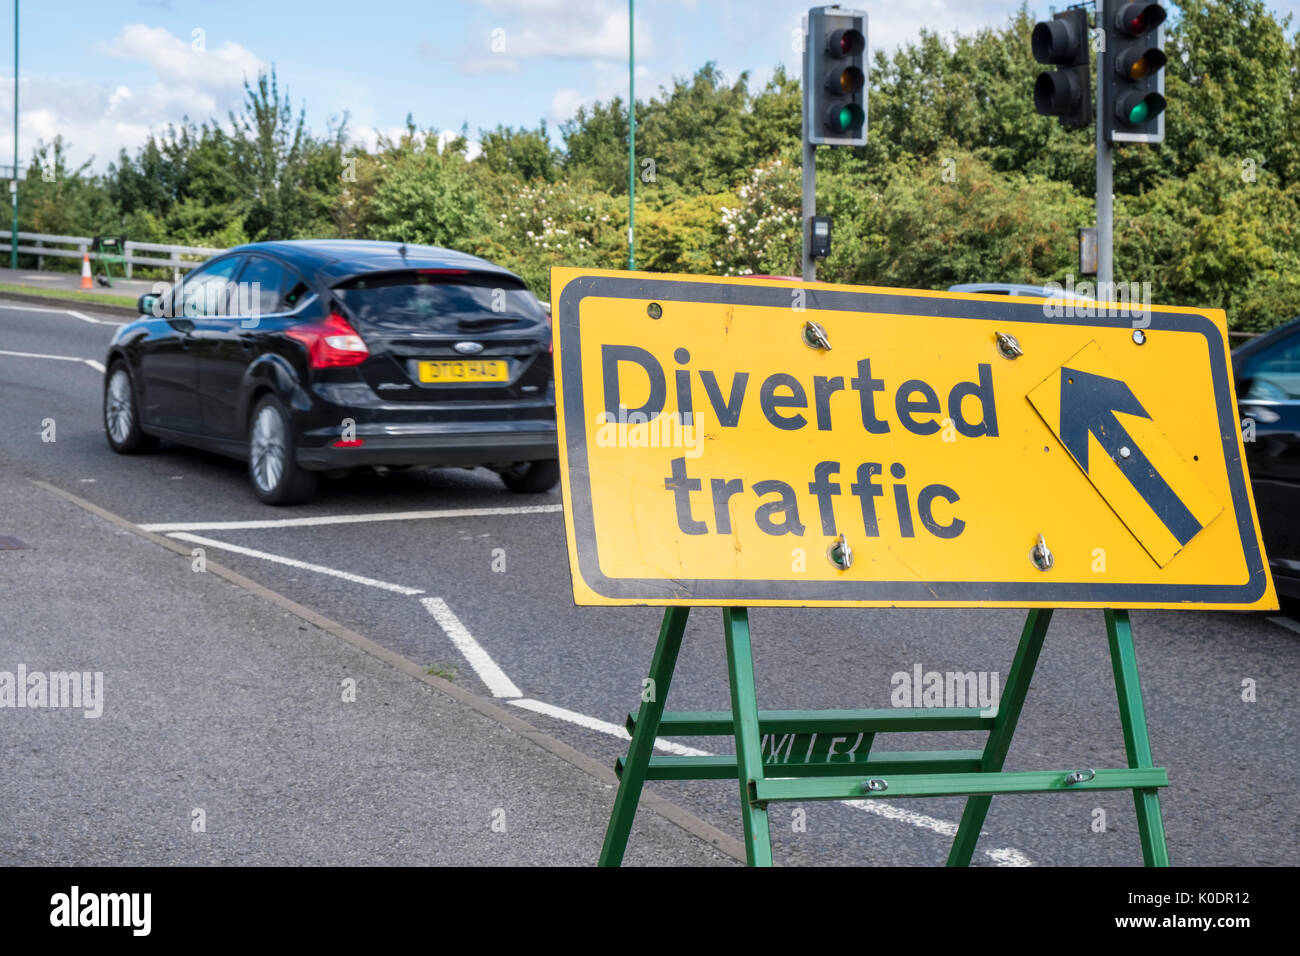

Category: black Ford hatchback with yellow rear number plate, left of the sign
[104, 239, 559, 505]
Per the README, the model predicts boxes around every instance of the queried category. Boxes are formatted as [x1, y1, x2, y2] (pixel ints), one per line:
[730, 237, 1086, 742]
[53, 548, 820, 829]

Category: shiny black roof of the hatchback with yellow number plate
[229, 239, 523, 282]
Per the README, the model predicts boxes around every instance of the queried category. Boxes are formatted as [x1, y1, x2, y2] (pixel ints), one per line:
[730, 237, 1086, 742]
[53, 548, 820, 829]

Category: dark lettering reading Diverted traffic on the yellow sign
[601, 345, 997, 538]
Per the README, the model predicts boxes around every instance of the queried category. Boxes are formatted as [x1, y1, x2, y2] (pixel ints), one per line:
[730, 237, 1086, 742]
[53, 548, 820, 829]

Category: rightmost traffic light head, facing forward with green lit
[1102, 4, 1167, 143]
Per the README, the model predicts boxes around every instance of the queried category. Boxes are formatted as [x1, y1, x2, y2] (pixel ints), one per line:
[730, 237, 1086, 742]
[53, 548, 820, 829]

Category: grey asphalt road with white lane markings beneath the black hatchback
[0, 304, 1300, 865]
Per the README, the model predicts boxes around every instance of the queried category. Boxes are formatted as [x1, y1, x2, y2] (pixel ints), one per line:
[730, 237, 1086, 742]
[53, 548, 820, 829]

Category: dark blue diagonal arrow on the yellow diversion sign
[1061, 367, 1203, 545]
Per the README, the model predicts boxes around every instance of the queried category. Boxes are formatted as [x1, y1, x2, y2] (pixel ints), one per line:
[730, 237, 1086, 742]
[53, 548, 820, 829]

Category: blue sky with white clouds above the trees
[0, 0, 1300, 168]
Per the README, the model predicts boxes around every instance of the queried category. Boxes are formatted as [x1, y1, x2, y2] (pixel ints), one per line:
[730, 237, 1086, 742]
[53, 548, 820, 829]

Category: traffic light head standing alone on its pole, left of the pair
[803, 7, 867, 146]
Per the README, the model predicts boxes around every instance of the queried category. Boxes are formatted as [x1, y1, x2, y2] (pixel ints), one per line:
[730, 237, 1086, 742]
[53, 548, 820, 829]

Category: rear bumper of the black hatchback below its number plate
[296, 421, 559, 471]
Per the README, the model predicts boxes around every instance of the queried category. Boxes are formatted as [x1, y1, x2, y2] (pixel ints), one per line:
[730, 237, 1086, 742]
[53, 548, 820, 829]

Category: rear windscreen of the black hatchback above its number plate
[334, 272, 546, 332]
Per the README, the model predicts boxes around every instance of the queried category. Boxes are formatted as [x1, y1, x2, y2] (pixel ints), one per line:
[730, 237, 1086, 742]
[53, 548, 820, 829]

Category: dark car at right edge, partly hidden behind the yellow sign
[1232, 319, 1300, 598]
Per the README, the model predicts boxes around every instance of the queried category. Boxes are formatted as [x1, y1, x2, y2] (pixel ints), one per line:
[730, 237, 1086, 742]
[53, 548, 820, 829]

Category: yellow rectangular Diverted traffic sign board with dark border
[551, 269, 1277, 609]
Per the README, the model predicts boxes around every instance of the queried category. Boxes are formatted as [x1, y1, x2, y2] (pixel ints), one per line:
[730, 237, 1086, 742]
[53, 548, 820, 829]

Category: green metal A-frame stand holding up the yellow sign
[601, 607, 1169, 866]
